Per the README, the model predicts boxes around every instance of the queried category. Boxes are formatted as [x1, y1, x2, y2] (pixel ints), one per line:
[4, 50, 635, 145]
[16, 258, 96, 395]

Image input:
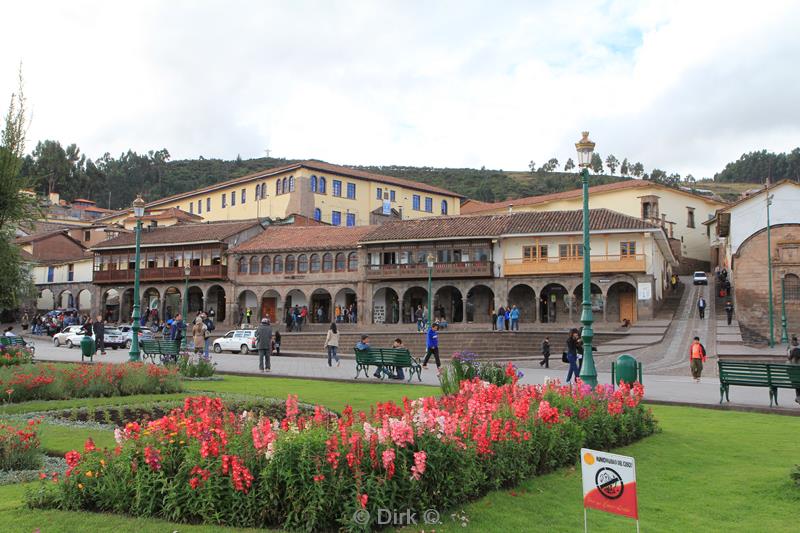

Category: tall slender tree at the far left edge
[0, 72, 40, 309]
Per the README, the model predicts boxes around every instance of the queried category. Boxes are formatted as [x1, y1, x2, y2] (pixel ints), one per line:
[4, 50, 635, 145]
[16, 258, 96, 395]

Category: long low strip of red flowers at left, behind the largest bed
[0, 363, 181, 402]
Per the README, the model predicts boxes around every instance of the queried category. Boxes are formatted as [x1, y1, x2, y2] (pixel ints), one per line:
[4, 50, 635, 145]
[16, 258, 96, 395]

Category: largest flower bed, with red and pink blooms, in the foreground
[27, 379, 656, 531]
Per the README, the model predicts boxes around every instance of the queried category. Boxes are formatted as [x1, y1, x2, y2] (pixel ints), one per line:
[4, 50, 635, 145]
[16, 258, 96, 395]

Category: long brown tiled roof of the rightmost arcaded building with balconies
[362, 209, 659, 242]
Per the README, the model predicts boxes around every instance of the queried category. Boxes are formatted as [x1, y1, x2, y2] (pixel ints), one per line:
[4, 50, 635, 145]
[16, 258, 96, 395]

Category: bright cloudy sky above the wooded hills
[0, 0, 800, 177]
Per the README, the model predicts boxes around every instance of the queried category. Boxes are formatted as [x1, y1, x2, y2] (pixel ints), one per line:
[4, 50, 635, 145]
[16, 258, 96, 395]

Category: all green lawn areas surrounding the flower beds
[0, 376, 800, 533]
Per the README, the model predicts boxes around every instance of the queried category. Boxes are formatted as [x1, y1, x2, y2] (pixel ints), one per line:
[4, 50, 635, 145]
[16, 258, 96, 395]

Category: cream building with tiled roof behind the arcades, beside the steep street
[462, 180, 727, 272]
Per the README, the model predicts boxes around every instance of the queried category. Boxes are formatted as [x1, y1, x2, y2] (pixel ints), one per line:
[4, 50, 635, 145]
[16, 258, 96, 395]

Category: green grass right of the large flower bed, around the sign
[400, 406, 800, 532]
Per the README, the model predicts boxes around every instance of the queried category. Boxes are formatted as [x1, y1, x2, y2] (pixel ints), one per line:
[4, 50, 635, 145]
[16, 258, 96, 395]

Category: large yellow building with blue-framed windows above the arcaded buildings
[103, 161, 462, 226]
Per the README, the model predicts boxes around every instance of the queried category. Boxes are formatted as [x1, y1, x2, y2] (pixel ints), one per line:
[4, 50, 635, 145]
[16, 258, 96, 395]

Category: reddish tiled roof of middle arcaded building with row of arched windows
[230, 226, 375, 254]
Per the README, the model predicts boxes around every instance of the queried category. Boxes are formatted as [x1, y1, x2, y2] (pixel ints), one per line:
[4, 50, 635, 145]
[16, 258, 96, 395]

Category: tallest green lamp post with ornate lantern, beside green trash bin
[575, 131, 597, 387]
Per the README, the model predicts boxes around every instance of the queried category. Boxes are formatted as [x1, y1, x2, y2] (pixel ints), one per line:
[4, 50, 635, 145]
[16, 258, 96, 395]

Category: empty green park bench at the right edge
[717, 360, 800, 407]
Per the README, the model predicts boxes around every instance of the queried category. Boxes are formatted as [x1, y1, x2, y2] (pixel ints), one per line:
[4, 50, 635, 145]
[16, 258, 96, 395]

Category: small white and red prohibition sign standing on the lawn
[581, 448, 639, 520]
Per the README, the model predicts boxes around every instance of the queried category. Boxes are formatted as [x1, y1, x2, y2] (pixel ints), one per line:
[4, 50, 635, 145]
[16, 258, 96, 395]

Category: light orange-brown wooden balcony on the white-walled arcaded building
[503, 254, 646, 276]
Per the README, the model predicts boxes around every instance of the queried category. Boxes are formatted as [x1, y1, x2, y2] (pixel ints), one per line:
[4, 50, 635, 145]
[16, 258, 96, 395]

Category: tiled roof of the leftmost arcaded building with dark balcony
[92, 219, 260, 250]
